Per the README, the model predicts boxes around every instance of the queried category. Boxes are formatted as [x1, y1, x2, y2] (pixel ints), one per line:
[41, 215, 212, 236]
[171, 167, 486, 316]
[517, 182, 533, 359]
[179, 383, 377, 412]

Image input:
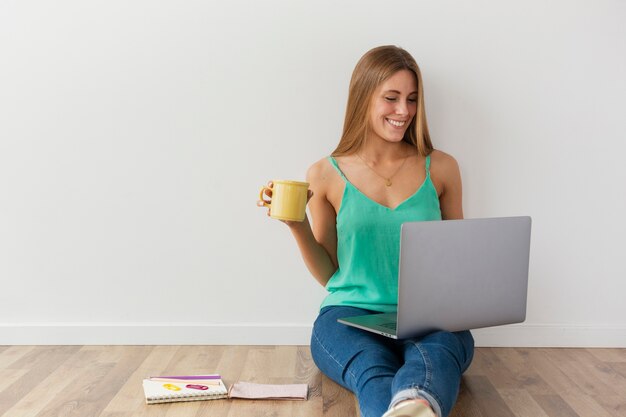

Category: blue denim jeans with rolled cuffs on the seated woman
[311, 306, 474, 417]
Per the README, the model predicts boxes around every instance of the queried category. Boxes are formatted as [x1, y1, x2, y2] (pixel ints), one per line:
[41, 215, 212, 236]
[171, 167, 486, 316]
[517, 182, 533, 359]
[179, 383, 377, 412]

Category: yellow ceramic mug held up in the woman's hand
[259, 180, 309, 222]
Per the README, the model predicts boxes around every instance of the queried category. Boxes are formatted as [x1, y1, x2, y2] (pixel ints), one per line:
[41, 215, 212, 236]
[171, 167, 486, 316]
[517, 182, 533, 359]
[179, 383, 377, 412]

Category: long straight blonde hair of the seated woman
[332, 45, 433, 156]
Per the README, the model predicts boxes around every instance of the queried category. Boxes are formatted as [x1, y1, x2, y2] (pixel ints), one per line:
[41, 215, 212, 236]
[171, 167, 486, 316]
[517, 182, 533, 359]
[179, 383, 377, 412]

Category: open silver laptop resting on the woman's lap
[338, 217, 531, 339]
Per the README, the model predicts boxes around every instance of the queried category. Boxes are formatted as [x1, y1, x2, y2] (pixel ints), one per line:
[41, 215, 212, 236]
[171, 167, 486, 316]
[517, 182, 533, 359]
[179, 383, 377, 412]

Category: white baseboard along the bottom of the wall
[0, 323, 626, 348]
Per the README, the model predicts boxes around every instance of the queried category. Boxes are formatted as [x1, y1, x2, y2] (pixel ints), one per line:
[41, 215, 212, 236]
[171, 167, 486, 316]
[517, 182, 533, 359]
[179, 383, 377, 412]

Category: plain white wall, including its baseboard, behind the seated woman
[0, 0, 626, 346]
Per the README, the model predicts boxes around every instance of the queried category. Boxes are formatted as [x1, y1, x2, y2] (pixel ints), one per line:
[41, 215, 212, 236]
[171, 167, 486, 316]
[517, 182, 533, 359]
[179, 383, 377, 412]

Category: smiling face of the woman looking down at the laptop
[369, 70, 417, 142]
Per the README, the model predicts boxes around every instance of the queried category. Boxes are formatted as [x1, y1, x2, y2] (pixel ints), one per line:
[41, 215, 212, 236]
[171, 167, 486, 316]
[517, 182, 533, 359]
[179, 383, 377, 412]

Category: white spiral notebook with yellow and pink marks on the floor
[143, 375, 228, 404]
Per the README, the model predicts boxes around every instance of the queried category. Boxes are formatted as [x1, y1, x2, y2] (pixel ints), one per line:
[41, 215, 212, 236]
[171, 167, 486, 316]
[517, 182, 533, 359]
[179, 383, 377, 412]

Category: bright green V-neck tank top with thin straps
[321, 155, 441, 313]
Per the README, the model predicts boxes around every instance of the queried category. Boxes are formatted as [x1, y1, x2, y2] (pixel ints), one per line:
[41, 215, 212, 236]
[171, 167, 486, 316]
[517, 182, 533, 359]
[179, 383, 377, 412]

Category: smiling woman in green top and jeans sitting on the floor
[259, 46, 474, 417]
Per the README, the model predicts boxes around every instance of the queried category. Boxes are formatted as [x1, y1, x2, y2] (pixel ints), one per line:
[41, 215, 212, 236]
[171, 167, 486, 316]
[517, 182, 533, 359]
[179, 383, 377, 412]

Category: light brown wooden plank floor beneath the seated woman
[0, 346, 626, 417]
